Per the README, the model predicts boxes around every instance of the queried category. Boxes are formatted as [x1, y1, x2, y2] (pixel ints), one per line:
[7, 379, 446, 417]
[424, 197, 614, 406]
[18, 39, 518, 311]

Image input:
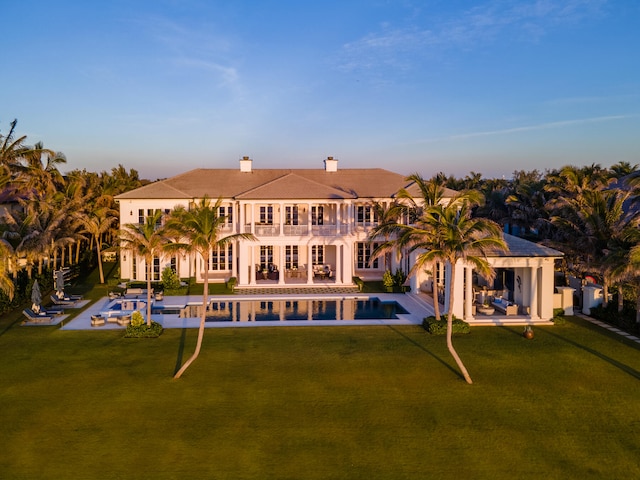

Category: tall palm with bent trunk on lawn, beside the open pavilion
[398, 190, 508, 384]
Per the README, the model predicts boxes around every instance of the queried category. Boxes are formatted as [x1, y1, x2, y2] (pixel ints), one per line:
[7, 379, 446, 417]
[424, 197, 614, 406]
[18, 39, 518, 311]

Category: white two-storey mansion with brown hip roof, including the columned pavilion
[116, 157, 562, 319]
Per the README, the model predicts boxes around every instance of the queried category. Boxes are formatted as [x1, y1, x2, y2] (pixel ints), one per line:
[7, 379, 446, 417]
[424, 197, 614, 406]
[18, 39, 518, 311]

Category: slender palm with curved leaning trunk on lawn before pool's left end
[167, 196, 255, 378]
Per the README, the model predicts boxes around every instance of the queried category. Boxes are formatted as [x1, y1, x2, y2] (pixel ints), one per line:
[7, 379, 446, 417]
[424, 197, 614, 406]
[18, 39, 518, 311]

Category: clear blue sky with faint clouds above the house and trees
[0, 0, 640, 180]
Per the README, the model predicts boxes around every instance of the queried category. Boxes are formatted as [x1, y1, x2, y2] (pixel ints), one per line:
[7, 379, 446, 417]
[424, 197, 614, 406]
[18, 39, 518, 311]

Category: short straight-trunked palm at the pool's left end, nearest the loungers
[120, 210, 171, 327]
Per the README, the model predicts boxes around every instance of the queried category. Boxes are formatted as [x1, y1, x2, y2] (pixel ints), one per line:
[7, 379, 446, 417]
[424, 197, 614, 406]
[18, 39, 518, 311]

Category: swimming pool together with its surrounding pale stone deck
[61, 293, 433, 330]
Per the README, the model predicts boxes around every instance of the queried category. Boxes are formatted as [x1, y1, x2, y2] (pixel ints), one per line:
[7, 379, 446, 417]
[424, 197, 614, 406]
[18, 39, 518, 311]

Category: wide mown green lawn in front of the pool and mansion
[0, 318, 640, 479]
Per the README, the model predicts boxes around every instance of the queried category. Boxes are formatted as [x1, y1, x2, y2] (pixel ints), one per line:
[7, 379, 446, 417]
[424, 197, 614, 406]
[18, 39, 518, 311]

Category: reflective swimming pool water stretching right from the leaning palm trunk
[206, 297, 409, 322]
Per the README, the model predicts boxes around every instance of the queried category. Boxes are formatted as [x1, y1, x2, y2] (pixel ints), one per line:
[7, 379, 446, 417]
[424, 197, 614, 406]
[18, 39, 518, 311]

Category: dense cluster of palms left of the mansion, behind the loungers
[0, 120, 142, 298]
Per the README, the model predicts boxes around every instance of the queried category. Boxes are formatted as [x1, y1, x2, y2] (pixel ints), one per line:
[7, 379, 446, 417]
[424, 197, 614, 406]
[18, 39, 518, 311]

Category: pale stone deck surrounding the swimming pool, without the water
[60, 293, 433, 330]
